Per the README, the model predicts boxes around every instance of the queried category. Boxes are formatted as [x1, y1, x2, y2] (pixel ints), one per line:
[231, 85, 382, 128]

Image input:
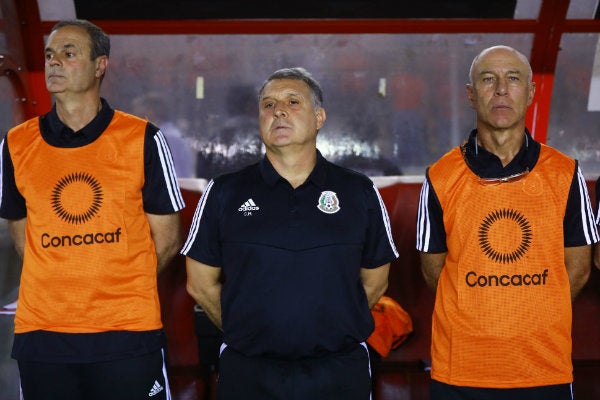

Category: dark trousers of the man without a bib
[217, 345, 371, 400]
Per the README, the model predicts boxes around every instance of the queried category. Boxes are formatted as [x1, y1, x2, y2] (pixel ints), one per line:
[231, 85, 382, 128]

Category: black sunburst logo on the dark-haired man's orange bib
[51, 172, 103, 225]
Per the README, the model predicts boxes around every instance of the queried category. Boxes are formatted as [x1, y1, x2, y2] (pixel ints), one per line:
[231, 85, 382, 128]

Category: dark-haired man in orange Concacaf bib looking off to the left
[0, 20, 184, 400]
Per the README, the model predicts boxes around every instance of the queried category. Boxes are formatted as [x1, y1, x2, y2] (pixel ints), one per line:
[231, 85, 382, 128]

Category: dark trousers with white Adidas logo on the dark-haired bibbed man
[18, 350, 171, 400]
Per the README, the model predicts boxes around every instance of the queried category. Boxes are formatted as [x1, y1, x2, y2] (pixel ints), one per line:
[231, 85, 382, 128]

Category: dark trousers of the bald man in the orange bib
[430, 379, 573, 400]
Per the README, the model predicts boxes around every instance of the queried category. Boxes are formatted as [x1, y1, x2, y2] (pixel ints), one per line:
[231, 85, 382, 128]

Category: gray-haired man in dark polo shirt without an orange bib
[182, 68, 398, 400]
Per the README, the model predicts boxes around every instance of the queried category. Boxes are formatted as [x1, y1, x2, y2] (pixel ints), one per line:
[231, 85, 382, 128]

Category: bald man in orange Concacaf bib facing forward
[417, 46, 600, 400]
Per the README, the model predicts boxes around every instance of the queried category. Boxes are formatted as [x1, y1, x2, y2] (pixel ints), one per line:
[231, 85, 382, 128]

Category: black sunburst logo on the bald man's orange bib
[479, 208, 532, 264]
